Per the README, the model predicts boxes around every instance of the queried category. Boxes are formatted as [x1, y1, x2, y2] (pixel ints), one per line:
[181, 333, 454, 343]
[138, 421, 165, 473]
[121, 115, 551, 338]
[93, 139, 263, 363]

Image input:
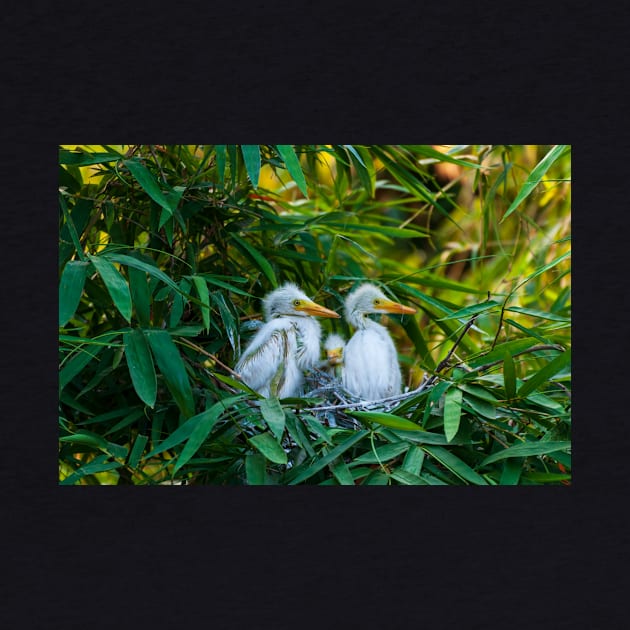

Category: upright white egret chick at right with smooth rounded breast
[342, 284, 416, 400]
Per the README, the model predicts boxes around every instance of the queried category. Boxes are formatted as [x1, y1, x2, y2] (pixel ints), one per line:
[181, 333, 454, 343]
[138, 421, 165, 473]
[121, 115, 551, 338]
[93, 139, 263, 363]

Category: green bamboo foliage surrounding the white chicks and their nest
[59, 145, 571, 485]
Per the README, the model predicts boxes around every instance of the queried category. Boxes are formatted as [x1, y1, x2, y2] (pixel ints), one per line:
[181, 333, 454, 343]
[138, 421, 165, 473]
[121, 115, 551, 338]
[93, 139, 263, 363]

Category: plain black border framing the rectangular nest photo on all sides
[0, 0, 629, 630]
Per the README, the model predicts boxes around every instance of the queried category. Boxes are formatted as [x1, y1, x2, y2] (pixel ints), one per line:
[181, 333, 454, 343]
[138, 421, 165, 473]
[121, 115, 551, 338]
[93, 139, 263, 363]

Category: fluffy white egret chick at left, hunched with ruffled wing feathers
[234, 282, 340, 398]
